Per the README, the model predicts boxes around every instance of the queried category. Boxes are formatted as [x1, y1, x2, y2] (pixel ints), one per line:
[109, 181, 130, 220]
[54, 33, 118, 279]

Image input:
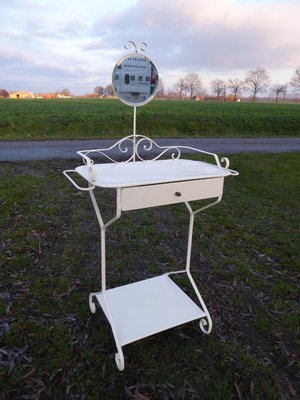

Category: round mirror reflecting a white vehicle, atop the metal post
[112, 53, 158, 106]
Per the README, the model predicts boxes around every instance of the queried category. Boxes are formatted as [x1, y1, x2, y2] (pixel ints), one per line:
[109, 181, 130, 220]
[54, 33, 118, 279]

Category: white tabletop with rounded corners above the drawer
[76, 159, 231, 188]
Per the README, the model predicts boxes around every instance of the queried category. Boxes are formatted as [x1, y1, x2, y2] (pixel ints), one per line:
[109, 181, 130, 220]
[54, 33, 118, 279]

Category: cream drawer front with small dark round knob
[121, 178, 224, 211]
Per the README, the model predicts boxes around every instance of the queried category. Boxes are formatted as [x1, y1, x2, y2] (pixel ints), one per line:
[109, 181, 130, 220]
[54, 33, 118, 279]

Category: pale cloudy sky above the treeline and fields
[0, 0, 300, 95]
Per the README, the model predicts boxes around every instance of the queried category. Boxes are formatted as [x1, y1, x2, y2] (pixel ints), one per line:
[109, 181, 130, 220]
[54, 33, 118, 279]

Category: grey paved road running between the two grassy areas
[0, 138, 300, 161]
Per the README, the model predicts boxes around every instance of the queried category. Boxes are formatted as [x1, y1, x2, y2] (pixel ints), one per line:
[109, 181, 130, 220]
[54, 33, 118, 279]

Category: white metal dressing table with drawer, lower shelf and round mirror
[64, 42, 238, 370]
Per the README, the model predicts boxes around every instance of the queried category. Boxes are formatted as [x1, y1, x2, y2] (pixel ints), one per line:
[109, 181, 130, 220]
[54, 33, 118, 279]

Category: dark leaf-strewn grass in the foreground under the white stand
[0, 154, 300, 400]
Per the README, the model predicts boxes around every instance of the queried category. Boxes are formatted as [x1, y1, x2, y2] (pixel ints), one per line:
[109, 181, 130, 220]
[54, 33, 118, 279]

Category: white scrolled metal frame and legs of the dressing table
[64, 134, 238, 371]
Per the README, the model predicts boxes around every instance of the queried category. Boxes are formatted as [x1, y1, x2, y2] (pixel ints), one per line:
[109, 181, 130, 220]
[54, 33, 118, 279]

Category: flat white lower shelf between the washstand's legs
[95, 275, 206, 346]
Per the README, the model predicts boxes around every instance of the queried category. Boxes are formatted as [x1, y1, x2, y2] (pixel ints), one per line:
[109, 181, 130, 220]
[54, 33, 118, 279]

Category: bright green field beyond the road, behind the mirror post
[0, 99, 300, 140]
